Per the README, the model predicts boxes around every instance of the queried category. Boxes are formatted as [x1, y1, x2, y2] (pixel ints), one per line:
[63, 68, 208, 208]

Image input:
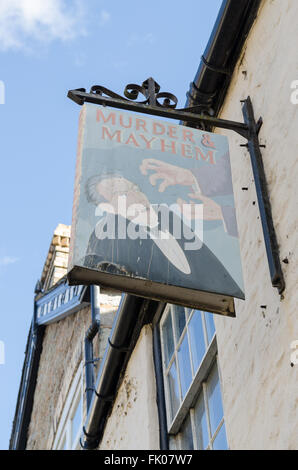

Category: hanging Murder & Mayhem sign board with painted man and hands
[68, 104, 244, 315]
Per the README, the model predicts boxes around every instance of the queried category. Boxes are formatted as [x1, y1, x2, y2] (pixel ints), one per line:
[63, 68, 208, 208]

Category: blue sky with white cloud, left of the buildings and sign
[0, 0, 221, 449]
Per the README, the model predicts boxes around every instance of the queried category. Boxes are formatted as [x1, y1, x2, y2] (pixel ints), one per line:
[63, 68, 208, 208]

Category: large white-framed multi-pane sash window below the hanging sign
[160, 305, 228, 450]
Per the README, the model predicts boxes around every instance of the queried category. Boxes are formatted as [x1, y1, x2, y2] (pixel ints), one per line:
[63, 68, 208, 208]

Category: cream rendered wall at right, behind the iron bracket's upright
[215, 0, 298, 449]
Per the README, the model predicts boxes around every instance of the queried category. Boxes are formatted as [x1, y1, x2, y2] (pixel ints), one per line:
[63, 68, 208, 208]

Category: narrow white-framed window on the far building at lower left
[53, 366, 83, 450]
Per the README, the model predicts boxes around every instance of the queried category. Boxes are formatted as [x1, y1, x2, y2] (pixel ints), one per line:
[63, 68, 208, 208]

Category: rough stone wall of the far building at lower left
[27, 291, 121, 450]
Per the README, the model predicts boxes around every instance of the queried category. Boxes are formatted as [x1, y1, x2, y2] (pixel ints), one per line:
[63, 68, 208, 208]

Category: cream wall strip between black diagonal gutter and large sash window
[100, 325, 159, 450]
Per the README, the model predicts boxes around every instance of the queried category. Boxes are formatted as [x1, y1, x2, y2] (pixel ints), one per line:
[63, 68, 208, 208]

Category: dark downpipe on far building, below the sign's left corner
[85, 285, 100, 410]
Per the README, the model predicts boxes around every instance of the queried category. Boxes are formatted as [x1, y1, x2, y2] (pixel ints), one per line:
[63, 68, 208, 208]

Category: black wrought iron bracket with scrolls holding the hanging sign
[67, 78, 285, 294]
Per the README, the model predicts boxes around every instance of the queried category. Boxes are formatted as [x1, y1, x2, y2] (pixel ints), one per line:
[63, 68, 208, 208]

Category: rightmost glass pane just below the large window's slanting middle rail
[207, 365, 223, 435]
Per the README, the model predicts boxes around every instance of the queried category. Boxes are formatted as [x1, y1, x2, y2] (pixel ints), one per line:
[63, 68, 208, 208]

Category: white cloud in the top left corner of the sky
[0, 0, 83, 50]
